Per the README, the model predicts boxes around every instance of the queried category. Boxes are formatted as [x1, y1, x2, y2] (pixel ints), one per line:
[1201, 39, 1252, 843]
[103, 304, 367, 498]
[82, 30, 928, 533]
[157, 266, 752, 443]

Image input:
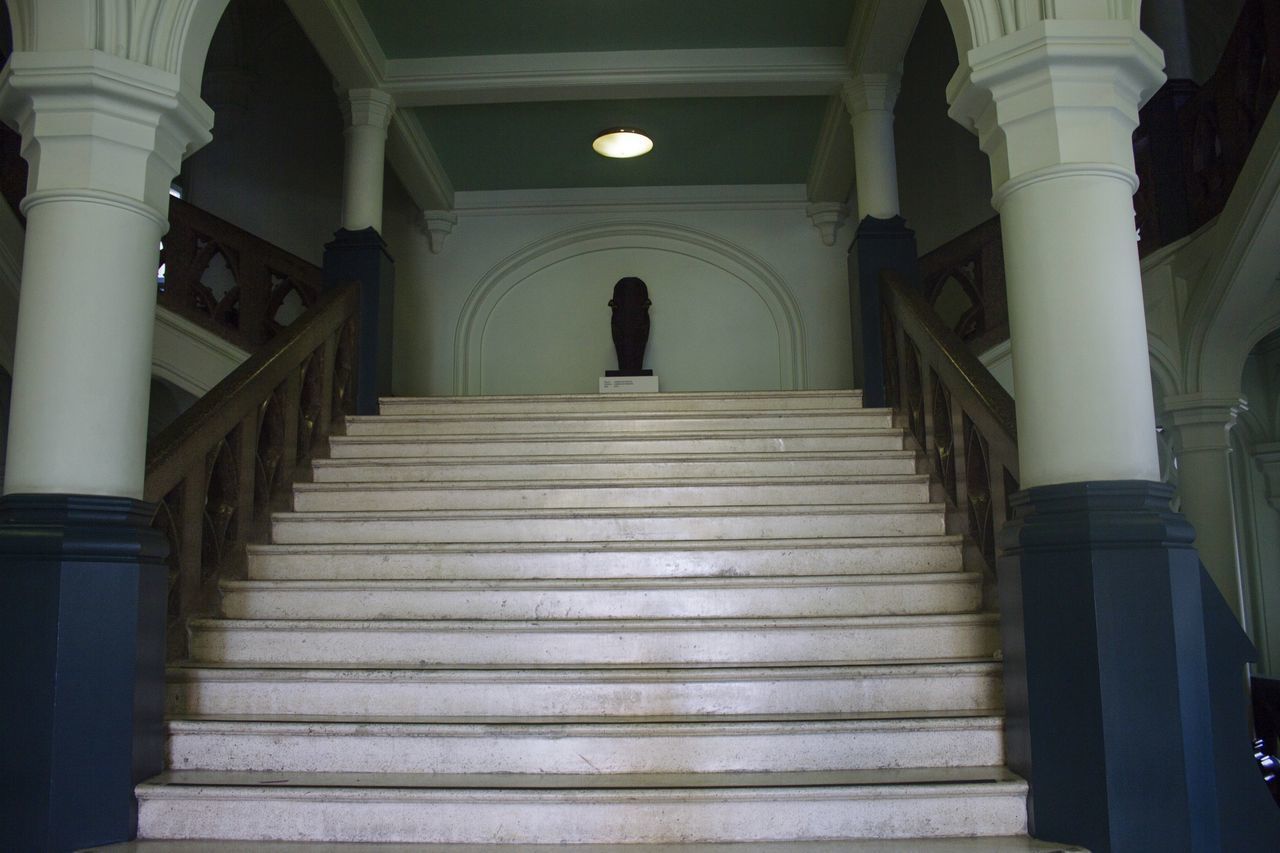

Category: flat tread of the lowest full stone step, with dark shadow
[138, 766, 1027, 798]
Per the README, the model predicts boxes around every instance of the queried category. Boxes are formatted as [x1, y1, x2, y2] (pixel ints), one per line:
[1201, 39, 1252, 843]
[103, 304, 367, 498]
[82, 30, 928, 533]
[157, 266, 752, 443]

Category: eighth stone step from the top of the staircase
[221, 571, 982, 620]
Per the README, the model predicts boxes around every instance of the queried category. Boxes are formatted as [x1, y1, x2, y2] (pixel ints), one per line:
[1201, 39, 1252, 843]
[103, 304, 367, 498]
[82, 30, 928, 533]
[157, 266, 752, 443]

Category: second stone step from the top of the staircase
[346, 409, 893, 437]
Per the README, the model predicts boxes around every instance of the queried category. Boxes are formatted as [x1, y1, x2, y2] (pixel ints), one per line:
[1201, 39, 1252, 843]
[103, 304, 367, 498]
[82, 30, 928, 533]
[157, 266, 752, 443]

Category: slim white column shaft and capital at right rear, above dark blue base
[841, 74, 901, 219]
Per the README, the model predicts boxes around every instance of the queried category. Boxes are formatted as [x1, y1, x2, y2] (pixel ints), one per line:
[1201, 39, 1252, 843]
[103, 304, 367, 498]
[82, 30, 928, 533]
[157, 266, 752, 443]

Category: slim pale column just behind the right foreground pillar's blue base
[1164, 393, 1244, 617]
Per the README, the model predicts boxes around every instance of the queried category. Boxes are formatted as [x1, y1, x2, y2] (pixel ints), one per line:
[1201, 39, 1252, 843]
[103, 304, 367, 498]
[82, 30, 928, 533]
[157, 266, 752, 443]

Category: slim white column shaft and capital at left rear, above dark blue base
[339, 88, 396, 233]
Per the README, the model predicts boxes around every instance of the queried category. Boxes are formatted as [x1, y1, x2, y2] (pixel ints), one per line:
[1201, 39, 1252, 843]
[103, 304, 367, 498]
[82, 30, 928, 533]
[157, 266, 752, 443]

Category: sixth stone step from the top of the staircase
[271, 503, 946, 544]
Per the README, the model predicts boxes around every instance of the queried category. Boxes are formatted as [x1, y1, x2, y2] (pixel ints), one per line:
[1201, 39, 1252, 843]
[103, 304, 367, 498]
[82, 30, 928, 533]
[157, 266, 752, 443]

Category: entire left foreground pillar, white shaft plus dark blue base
[0, 48, 216, 850]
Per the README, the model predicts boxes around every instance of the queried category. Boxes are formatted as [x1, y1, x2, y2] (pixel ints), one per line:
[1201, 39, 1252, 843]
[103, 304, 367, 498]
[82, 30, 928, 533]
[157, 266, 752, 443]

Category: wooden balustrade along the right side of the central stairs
[881, 272, 1018, 593]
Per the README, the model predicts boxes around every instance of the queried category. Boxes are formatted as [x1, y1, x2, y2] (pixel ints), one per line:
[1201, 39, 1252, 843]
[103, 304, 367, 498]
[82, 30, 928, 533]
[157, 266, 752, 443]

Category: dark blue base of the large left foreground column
[0, 494, 169, 850]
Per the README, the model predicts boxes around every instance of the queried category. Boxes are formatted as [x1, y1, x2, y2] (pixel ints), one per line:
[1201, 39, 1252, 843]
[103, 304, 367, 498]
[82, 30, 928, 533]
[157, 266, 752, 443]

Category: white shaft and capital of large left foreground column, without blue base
[0, 51, 212, 498]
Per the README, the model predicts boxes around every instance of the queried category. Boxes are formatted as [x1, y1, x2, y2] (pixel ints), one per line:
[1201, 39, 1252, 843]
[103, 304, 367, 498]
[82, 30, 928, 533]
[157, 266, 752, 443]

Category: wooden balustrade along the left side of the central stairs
[143, 283, 360, 657]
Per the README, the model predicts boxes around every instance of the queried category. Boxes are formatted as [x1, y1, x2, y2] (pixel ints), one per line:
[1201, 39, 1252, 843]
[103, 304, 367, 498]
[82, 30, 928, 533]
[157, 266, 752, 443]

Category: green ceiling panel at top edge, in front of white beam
[360, 0, 852, 59]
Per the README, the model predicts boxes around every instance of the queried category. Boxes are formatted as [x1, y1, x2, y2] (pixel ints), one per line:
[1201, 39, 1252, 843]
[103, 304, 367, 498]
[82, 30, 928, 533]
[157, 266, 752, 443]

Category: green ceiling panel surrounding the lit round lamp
[415, 97, 827, 191]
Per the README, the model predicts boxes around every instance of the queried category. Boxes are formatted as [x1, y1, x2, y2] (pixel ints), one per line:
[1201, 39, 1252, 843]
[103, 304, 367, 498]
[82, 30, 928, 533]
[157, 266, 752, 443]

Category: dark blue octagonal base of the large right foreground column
[998, 482, 1280, 853]
